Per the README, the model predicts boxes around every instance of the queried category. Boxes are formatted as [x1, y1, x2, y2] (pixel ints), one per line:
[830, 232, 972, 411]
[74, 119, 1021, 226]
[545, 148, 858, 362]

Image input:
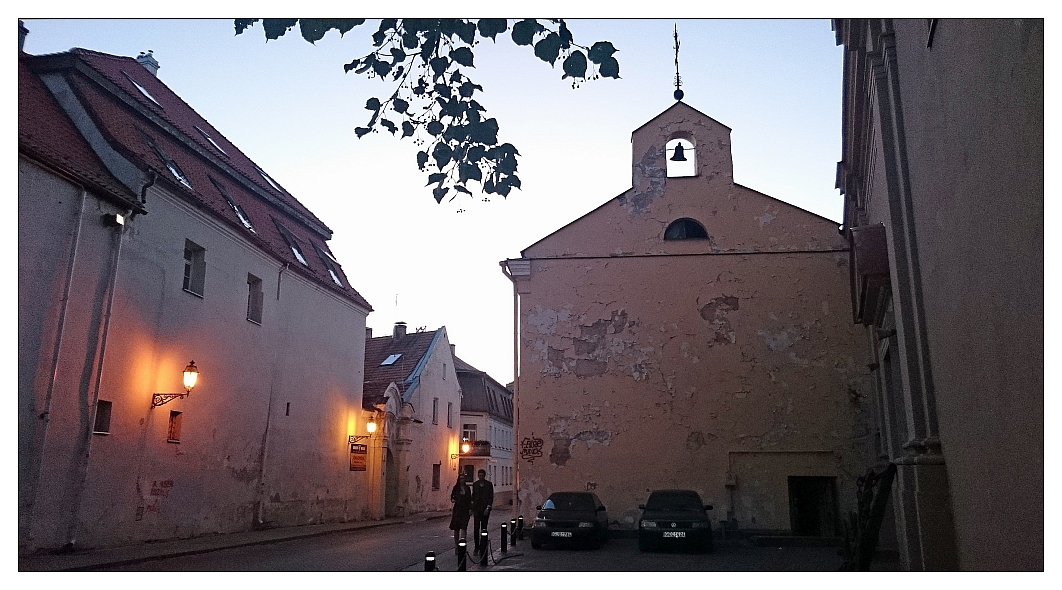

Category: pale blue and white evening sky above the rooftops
[16, 19, 842, 383]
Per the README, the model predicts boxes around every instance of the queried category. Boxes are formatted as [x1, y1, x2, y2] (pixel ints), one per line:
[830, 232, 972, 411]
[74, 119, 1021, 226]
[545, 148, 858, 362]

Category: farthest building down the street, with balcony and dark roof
[453, 357, 516, 504]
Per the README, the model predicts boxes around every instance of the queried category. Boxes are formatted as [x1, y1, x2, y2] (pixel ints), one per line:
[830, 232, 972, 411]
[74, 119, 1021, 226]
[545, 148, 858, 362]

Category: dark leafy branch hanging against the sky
[235, 18, 619, 203]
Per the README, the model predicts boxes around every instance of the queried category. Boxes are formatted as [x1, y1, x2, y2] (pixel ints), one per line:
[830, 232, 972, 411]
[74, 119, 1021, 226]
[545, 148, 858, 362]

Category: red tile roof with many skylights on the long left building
[19, 49, 372, 311]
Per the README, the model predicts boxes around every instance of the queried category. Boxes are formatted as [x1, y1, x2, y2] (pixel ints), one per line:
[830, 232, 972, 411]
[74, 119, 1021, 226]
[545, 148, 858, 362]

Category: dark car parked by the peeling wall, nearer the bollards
[531, 491, 609, 549]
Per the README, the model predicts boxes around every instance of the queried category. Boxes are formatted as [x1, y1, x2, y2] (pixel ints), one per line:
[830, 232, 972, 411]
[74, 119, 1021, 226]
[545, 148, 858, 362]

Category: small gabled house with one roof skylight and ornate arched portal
[364, 322, 461, 517]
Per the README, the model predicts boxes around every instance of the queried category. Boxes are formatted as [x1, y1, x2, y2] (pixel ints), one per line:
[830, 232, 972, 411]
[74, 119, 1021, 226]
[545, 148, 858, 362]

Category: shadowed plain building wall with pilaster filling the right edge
[834, 19, 1045, 570]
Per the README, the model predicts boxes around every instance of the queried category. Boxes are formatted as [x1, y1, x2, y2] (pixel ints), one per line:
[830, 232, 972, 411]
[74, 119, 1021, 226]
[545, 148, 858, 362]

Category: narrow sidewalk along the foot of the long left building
[18, 510, 452, 572]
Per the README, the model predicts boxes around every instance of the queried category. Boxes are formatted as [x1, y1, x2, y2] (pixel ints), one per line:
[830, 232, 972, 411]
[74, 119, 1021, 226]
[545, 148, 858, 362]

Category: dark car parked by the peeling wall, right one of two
[638, 489, 713, 553]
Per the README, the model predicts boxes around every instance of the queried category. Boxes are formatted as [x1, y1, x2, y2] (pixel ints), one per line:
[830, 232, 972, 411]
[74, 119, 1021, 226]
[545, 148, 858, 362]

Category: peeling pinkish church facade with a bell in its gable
[502, 102, 871, 536]
